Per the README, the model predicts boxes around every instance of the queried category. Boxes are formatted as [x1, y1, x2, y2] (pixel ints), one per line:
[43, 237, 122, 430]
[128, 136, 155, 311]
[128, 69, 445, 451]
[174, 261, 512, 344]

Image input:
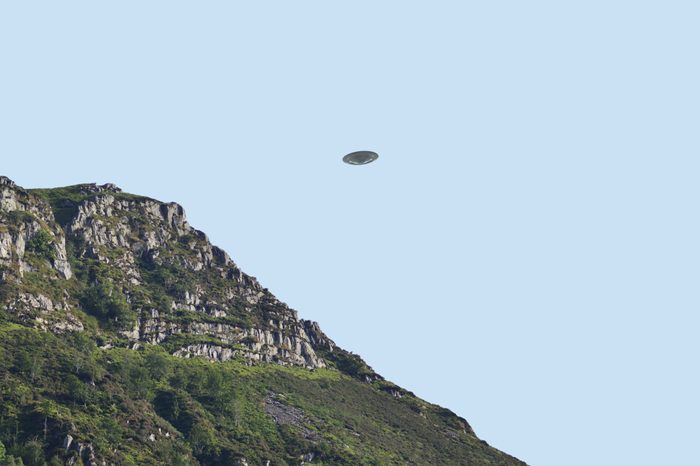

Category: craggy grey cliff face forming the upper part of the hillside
[0, 177, 333, 368]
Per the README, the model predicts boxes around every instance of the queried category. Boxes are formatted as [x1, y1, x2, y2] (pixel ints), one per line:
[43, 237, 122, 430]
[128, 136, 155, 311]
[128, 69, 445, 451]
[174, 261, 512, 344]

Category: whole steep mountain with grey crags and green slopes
[0, 177, 525, 466]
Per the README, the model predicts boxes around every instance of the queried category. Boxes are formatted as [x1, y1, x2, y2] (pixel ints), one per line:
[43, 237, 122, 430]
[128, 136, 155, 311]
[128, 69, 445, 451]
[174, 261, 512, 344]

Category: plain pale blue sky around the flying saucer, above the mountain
[0, 0, 700, 466]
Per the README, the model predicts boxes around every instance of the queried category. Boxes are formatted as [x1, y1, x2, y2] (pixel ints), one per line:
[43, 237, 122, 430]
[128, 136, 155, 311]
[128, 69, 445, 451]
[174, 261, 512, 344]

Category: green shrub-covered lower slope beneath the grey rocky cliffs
[0, 324, 516, 465]
